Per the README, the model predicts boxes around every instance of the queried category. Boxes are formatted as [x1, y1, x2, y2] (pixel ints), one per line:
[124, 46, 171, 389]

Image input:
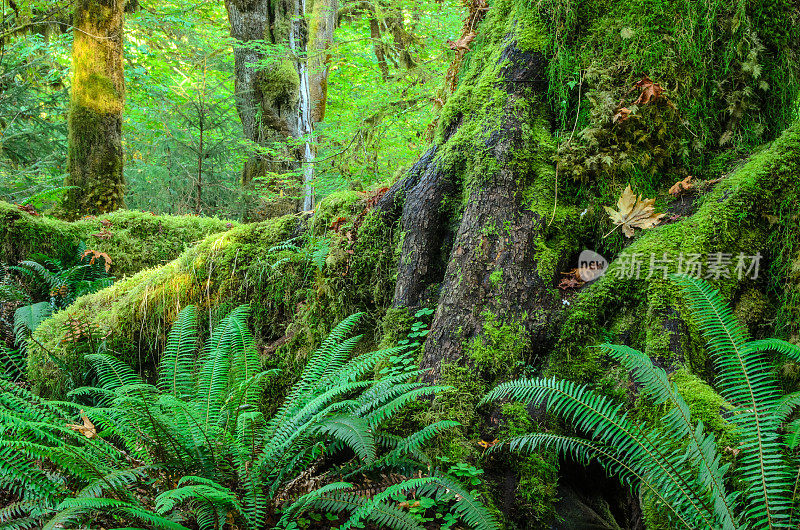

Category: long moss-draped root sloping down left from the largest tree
[28, 192, 395, 396]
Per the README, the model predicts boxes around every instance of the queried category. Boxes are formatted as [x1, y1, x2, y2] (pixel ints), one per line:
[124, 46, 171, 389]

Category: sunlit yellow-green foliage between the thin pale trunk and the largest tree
[315, 0, 463, 197]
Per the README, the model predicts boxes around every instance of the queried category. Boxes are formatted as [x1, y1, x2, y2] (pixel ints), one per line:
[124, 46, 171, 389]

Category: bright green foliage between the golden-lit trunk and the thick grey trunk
[123, 0, 246, 214]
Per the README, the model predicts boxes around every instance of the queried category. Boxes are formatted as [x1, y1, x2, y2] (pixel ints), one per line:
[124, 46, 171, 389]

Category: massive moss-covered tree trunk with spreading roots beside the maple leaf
[380, 0, 800, 526]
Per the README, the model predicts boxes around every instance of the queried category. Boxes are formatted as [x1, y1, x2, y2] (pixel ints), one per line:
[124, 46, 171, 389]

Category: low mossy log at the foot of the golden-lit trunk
[0, 201, 238, 278]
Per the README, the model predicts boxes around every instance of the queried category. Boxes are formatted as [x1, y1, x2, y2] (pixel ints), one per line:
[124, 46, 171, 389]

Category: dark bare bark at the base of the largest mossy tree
[387, 25, 555, 380]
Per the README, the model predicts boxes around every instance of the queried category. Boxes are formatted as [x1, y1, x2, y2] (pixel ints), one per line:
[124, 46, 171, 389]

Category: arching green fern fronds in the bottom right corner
[483, 275, 800, 528]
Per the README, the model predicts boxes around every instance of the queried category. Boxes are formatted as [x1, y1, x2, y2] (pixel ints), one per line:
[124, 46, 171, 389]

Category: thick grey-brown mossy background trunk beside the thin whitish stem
[225, 0, 316, 219]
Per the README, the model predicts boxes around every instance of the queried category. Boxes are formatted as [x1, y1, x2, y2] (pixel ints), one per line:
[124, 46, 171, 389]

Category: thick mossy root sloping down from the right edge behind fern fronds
[549, 119, 800, 381]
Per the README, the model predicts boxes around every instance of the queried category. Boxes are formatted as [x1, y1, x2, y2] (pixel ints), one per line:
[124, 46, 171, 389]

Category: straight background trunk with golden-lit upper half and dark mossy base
[64, 0, 125, 217]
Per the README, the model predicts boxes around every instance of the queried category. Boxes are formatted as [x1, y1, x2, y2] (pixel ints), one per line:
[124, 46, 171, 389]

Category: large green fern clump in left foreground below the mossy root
[0, 306, 496, 529]
